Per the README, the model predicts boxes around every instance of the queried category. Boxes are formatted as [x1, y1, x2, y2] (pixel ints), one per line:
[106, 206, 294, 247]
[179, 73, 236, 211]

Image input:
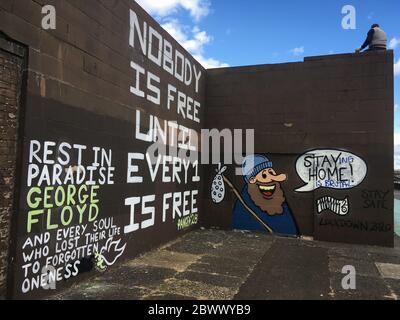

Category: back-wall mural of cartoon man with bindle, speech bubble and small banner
[210, 149, 370, 236]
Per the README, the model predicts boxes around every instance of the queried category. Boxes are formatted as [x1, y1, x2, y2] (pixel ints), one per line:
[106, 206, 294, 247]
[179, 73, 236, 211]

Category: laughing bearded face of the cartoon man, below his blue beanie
[248, 168, 287, 216]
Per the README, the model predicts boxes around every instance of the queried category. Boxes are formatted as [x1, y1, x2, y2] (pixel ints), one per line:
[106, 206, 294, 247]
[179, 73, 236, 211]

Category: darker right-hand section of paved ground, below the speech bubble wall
[235, 238, 400, 300]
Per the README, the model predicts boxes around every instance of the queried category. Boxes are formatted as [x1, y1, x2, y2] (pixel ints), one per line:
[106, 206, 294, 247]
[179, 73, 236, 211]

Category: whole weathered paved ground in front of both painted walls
[51, 230, 400, 300]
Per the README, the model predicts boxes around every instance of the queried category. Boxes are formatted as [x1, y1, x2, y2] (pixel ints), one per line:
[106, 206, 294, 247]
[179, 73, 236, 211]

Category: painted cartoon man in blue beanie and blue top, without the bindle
[233, 155, 299, 236]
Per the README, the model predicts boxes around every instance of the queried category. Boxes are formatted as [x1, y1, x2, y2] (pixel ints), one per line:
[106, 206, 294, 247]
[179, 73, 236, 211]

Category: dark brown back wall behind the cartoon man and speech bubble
[203, 51, 393, 246]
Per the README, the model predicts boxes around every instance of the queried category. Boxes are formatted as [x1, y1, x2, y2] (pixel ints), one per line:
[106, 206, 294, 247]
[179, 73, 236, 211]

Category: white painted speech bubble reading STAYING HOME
[295, 149, 368, 192]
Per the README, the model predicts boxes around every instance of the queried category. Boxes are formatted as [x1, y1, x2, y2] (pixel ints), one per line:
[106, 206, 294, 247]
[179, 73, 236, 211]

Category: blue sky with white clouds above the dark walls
[137, 0, 400, 169]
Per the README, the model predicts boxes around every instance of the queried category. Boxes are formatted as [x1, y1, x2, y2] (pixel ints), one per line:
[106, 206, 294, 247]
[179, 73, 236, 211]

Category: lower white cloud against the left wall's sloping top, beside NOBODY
[162, 19, 229, 68]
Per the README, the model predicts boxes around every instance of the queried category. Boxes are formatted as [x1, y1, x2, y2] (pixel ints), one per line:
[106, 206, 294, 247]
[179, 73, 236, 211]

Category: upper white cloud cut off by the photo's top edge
[136, 0, 210, 21]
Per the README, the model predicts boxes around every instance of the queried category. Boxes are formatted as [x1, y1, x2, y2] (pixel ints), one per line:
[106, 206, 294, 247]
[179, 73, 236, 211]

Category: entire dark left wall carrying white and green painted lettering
[0, 0, 206, 298]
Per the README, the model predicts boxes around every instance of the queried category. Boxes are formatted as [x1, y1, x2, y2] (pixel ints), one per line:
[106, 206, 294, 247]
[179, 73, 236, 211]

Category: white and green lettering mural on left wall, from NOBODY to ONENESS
[12, 2, 205, 299]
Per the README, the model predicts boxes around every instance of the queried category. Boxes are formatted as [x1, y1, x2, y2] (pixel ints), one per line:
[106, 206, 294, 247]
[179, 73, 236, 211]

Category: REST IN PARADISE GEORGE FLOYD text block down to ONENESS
[20, 140, 125, 293]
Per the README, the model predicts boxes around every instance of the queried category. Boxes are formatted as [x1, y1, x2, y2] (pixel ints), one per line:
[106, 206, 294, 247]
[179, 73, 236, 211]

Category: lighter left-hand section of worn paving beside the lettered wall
[48, 230, 274, 300]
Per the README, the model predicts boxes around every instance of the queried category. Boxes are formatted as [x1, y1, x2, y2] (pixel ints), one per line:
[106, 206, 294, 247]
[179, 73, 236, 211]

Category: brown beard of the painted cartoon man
[248, 182, 286, 216]
